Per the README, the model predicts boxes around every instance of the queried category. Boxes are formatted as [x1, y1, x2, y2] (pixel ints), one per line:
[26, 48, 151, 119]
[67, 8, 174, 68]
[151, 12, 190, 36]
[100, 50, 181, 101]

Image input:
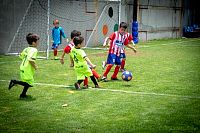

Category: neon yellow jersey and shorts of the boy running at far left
[19, 47, 38, 85]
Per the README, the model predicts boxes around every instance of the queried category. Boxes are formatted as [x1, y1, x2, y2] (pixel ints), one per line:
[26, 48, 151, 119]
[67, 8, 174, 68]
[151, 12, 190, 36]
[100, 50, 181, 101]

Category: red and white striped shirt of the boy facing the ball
[109, 31, 129, 56]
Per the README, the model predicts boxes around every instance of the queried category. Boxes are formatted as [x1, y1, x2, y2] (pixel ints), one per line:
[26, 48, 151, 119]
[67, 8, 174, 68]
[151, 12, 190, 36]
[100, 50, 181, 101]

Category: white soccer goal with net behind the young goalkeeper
[8, 0, 119, 58]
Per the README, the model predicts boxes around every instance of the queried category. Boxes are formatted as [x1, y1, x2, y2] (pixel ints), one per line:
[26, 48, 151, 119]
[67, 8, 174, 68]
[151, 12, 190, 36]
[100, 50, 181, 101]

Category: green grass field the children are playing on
[0, 39, 200, 133]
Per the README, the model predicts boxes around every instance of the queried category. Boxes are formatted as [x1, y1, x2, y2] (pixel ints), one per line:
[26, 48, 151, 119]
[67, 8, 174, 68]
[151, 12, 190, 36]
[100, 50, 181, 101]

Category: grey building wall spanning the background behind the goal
[0, 0, 200, 56]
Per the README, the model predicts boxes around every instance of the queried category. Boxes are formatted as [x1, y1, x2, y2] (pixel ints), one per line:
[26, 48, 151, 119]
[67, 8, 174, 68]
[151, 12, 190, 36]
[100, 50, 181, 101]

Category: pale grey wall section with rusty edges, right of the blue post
[138, 0, 182, 41]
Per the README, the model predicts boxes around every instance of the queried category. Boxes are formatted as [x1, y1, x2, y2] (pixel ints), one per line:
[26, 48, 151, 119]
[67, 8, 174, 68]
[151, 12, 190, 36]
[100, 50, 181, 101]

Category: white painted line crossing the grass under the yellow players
[0, 80, 200, 99]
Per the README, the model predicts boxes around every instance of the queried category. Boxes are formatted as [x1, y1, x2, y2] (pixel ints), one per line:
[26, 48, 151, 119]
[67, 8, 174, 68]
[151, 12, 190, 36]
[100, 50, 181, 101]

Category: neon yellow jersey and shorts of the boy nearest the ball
[70, 48, 92, 80]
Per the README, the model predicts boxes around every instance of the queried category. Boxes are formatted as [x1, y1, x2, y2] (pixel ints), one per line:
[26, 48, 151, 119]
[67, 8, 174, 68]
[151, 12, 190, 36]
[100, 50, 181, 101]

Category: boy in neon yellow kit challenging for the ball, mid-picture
[69, 36, 99, 89]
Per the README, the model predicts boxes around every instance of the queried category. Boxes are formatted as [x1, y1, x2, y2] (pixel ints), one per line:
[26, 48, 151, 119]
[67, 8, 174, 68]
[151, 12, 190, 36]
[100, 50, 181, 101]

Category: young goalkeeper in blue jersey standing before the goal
[52, 19, 68, 60]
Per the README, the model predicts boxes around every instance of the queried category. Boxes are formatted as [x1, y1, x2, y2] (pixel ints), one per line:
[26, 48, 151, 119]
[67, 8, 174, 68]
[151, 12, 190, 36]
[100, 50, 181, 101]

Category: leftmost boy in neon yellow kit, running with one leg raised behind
[8, 33, 39, 98]
